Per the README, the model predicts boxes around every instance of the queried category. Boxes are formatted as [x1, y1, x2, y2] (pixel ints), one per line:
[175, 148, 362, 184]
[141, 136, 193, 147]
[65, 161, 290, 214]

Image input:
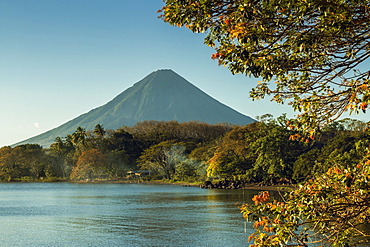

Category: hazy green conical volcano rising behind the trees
[17, 69, 255, 147]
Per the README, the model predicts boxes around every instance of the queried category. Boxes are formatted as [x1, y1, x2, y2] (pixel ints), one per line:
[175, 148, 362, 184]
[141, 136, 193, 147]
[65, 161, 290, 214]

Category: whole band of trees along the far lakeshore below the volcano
[0, 115, 369, 186]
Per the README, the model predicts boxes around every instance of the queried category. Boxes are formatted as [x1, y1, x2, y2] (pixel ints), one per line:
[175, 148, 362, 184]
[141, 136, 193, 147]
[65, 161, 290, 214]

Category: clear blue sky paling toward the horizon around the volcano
[0, 0, 365, 147]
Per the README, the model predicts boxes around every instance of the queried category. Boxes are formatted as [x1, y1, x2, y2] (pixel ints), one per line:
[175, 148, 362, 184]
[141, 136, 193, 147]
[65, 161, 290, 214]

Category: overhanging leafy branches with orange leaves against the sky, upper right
[159, 0, 370, 134]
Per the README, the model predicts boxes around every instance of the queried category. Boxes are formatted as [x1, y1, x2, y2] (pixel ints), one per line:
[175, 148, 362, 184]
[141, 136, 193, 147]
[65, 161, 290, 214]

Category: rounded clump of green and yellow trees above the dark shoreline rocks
[207, 120, 308, 184]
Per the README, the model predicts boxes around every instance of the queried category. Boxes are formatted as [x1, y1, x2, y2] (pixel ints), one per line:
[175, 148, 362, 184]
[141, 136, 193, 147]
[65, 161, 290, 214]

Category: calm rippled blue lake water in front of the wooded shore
[0, 183, 264, 246]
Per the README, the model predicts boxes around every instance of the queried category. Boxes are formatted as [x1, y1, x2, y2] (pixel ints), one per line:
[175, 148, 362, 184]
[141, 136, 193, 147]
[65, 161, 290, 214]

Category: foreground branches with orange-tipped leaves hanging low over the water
[241, 152, 370, 246]
